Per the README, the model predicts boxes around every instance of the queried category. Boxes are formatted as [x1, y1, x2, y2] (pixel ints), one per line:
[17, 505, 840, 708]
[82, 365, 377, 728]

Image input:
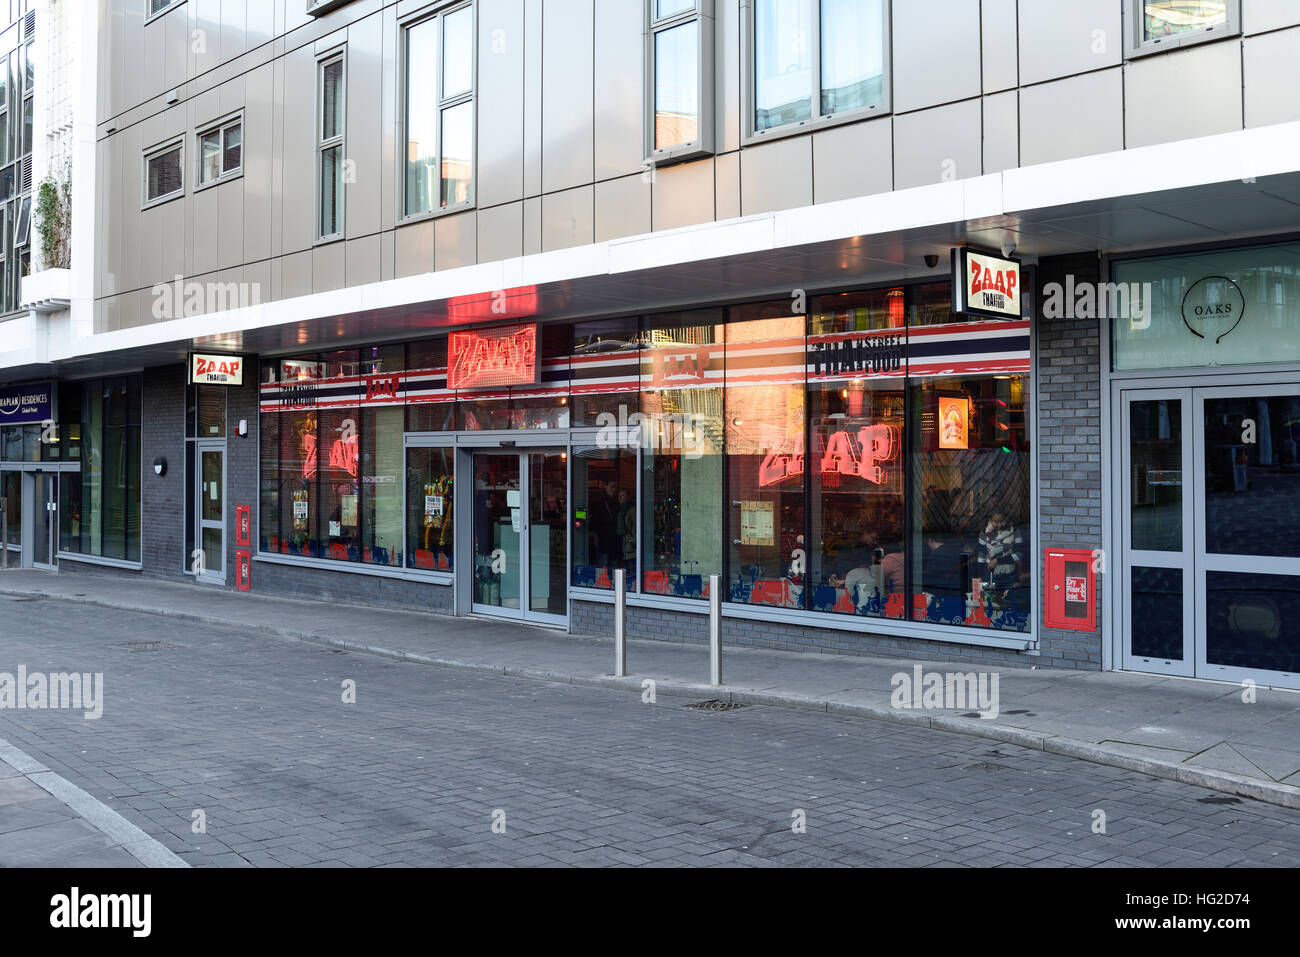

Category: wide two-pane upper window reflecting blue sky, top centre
[745, 0, 889, 138]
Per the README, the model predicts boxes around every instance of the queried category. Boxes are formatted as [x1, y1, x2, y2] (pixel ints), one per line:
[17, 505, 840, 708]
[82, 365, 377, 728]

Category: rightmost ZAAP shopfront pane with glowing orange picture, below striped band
[909, 376, 1034, 632]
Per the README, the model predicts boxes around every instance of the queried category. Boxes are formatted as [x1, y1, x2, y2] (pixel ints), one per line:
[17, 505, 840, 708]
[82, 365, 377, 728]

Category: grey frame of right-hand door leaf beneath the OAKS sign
[1191, 380, 1300, 689]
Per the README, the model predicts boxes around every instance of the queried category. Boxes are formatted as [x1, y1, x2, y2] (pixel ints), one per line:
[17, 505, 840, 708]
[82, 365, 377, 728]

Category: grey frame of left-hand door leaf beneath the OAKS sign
[1115, 389, 1197, 677]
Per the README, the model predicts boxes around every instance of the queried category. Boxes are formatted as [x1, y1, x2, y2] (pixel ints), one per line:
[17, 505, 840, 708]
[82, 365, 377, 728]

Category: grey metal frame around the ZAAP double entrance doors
[454, 429, 573, 628]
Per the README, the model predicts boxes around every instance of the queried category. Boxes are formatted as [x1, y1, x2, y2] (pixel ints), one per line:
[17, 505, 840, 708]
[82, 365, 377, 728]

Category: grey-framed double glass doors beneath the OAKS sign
[1118, 385, 1300, 688]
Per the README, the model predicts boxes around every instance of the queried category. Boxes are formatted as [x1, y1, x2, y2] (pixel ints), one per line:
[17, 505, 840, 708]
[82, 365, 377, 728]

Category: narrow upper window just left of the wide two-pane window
[645, 0, 714, 161]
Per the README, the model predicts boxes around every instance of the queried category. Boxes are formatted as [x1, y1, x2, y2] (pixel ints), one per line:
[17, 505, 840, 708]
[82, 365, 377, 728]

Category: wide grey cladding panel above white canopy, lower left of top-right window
[1019, 66, 1125, 166]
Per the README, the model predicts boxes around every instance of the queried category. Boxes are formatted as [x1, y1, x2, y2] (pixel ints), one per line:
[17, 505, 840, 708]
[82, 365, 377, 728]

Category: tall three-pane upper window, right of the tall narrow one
[403, 4, 475, 216]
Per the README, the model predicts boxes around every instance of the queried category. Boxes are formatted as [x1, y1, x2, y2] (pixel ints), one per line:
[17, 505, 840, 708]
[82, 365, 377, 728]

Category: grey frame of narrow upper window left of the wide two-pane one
[641, 0, 716, 166]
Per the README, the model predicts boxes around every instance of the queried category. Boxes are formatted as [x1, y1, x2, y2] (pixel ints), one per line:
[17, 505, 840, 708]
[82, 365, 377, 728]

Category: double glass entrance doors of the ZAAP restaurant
[471, 451, 568, 624]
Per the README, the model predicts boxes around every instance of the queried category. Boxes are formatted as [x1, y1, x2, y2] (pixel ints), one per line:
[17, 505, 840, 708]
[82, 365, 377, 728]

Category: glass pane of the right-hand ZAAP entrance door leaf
[528, 452, 569, 615]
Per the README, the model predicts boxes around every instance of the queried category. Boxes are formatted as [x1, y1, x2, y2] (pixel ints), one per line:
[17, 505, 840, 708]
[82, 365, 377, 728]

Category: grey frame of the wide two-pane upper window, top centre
[740, 0, 893, 146]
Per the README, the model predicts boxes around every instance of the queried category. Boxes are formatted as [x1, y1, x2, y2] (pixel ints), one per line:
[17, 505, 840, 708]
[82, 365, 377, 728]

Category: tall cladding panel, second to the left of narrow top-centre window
[542, 0, 594, 195]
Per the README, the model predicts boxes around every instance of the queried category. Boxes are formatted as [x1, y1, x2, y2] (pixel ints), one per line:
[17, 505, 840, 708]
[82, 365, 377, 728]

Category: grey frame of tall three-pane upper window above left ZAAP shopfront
[395, 0, 478, 225]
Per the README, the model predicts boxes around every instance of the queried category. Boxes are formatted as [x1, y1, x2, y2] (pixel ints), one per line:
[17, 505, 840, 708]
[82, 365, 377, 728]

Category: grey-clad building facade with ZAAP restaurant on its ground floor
[0, 0, 1300, 687]
